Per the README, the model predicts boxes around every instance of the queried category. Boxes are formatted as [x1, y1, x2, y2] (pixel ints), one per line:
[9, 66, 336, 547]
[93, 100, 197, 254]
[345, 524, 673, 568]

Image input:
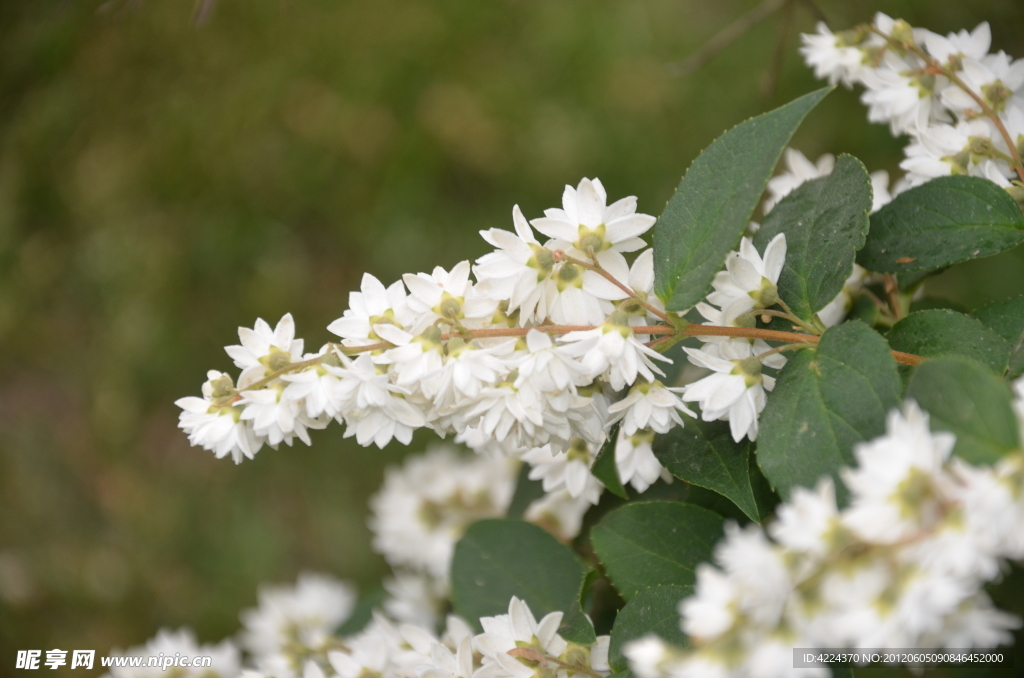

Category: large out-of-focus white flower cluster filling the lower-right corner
[626, 387, 1024, 678]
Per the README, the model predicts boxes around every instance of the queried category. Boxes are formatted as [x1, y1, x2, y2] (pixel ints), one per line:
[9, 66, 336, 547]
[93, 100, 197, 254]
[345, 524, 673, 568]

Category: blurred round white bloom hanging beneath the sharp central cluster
[370, 447, 516, 582]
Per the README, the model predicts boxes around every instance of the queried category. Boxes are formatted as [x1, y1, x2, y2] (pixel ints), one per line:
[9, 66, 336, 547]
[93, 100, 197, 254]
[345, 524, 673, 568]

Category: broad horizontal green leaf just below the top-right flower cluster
[857, 176, 1024, 273]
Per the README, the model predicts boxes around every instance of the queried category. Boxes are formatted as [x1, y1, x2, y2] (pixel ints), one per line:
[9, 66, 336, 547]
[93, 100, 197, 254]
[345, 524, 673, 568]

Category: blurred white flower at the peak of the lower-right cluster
[843, 400, 955, 543]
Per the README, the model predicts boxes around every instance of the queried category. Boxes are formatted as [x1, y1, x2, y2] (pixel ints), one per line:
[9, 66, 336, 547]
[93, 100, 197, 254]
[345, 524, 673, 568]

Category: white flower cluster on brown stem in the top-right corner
[801, 13, 1024, 193]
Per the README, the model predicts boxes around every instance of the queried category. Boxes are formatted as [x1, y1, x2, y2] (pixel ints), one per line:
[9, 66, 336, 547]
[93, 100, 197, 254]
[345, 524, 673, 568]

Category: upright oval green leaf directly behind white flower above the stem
[754, 156, 871, 321]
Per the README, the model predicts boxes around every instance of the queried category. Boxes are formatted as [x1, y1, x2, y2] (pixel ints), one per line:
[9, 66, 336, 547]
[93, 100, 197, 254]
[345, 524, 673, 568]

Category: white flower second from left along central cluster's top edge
[327, 273, 417, 346]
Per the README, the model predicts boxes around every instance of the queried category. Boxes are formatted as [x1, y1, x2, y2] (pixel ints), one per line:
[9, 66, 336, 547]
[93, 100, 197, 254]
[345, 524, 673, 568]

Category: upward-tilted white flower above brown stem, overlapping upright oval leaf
[708, 234, 785, 317]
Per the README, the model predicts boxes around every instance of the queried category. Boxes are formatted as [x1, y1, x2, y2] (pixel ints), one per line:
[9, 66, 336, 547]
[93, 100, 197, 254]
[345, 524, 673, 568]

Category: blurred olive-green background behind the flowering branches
[0, 0, 1024, 659]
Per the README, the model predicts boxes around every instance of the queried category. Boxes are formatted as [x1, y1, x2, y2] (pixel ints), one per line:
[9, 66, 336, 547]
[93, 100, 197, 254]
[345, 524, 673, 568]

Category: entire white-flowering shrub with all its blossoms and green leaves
[112, 9, 1024, 678]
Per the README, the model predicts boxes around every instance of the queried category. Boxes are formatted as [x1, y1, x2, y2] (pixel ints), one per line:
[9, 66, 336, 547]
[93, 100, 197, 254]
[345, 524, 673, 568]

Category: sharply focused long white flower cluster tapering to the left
[177, 179, 696, 516]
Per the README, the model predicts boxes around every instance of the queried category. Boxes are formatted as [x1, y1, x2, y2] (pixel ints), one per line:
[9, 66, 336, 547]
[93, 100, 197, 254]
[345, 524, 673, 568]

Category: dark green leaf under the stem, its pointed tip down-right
[654, 415, 775, 522]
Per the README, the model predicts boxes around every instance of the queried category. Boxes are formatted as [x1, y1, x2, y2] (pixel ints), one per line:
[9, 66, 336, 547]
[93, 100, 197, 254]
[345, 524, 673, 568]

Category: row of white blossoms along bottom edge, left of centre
[101, 575, 611, 678]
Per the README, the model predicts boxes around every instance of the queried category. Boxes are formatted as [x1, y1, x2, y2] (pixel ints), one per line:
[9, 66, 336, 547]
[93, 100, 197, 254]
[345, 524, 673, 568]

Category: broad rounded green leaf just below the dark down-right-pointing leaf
[591, 502, 724, 600]
